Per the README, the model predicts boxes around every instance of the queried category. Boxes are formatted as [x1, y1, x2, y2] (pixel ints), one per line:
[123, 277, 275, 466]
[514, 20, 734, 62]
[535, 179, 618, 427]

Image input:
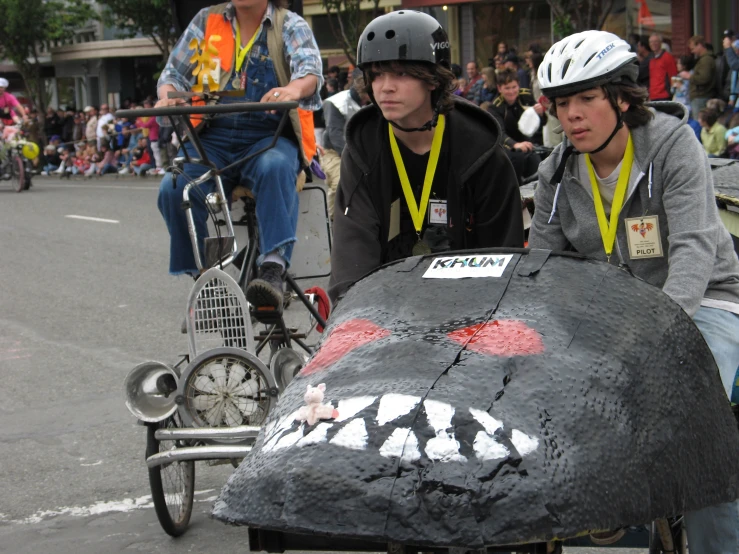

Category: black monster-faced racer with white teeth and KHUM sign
[213, 249, 739, 552]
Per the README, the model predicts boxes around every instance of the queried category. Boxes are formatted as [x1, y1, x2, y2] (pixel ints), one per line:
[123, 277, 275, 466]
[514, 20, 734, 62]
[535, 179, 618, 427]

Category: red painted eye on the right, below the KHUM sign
[447, 320, 544, 357]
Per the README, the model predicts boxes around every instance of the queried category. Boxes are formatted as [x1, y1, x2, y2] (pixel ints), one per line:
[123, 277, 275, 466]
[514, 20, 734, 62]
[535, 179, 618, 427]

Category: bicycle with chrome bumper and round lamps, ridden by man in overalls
[117, 98, 330, 536]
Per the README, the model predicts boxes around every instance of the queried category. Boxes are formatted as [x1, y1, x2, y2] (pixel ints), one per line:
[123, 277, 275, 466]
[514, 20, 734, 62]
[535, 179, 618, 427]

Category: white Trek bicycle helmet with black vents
[539, 31, 639, 99]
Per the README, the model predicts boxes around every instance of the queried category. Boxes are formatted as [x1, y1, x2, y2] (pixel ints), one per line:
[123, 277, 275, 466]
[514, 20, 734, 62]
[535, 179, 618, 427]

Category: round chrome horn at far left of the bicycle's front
[124, 361, 178, 423]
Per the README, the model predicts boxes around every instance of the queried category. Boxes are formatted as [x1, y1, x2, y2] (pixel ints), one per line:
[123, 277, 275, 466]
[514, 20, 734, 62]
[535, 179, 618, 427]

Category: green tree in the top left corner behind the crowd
[0, 0, 97, 113]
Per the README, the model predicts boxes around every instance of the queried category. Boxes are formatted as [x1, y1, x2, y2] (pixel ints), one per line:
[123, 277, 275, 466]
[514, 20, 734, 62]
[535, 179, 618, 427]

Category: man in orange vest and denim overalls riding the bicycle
[155, 0, 322, 311]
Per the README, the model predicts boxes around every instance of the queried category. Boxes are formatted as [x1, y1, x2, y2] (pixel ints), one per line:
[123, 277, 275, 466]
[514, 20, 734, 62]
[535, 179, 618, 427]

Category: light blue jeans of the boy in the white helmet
[685, 307, 739, 554]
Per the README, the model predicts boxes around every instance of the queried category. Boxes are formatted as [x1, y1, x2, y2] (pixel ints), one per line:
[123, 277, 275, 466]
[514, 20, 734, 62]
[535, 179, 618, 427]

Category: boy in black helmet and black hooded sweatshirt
[329, 10, 523, 301]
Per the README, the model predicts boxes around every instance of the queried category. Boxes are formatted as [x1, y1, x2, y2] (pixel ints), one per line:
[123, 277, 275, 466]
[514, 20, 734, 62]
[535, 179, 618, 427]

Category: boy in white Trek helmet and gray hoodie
[529, 31, 739, 554]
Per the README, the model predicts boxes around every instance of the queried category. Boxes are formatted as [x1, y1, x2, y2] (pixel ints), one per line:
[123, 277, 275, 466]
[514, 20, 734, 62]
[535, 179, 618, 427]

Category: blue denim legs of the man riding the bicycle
[157, 121, 300, 275]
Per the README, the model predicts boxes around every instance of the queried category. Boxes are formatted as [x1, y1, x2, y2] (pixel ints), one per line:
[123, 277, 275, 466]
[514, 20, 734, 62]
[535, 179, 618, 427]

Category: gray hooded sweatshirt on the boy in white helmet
[529, 102, 739, 316]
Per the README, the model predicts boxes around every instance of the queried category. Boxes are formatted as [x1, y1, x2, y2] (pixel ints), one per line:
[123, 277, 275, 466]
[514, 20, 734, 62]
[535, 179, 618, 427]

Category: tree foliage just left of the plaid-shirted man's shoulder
[98, 0, 176, 63]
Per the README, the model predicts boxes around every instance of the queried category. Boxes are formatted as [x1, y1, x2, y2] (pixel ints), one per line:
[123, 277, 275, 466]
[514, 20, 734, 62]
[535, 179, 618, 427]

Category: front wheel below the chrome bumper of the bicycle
[146, 412, 195, 537]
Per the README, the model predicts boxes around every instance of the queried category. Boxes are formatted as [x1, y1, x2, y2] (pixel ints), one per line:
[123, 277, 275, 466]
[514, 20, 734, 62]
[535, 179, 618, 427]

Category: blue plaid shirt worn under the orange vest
[157, 2, 323, 111]
